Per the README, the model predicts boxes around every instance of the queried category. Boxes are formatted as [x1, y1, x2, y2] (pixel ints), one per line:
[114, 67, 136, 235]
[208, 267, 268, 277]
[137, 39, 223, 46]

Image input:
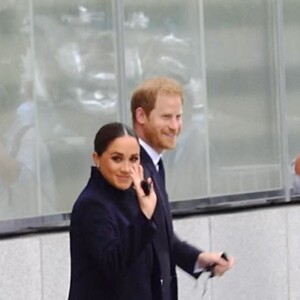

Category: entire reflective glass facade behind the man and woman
[0, 0, 300, 220]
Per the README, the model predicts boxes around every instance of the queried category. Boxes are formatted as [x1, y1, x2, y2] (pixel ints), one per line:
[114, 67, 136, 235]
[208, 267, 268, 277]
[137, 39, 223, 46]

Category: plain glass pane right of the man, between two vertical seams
[204, 1, 282, 195]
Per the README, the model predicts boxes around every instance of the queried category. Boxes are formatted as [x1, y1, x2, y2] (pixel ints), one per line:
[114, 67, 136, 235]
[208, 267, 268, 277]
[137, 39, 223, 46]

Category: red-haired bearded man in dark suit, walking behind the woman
[131, 77, 233, 300]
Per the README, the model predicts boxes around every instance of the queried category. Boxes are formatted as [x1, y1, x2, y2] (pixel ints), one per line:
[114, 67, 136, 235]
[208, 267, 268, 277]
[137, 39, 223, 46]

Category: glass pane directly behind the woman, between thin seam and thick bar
[33, 0, 118, 214]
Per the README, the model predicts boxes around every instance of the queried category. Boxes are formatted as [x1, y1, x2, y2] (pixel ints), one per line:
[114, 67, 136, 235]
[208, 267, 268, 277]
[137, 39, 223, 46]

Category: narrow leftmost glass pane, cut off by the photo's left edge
[0, 0, 38, 219]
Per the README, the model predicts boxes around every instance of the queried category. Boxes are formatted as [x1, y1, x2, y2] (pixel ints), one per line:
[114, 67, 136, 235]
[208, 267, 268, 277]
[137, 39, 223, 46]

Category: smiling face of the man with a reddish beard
[143, 94, 182, 153]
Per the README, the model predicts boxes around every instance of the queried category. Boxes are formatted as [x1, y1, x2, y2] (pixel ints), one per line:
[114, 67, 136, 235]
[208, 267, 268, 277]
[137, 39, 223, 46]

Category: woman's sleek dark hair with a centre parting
[94, 122, 138, 155]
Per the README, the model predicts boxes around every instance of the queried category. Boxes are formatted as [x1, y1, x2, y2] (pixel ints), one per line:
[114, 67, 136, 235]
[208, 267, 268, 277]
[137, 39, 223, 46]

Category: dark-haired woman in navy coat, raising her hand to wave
[69, 123, 161, 300]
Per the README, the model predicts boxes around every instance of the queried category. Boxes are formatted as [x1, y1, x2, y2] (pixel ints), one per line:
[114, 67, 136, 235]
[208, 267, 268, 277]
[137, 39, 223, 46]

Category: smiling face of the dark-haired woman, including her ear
[93, 136, 140, 190]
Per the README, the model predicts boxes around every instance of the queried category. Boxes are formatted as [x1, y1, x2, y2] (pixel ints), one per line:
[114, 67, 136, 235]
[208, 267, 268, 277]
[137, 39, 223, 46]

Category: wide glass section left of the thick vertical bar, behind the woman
[0, 0, 119, 219]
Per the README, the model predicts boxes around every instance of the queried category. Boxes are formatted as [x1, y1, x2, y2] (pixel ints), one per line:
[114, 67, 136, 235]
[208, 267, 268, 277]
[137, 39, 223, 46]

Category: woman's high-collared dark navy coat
[69, 167, 161, 300]
